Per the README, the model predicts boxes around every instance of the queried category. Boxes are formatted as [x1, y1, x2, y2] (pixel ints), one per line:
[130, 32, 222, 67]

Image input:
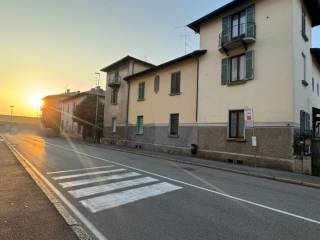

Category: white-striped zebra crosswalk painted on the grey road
[47, 165, 182, 213]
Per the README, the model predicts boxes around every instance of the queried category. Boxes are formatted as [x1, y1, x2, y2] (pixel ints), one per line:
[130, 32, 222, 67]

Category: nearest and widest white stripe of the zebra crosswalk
[80, 182, 182, 213]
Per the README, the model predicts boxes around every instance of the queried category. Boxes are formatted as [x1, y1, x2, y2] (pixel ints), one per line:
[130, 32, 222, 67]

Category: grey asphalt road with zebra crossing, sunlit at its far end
[2, 130, 320, 240]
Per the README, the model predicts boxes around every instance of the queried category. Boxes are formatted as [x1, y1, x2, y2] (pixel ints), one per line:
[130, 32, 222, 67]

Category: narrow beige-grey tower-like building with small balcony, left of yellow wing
[101, 56, 154, 143]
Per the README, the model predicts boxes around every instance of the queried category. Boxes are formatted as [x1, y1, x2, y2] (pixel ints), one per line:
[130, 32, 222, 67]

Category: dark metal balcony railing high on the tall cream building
[219, 23, 256, 47]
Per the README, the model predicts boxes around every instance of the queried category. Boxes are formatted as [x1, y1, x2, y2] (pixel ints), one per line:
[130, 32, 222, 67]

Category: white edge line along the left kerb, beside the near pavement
[5, 139, 108, 240]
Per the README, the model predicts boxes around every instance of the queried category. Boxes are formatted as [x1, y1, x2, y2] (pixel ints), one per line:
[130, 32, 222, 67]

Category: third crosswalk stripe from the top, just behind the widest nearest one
[69, 177, 158, 198]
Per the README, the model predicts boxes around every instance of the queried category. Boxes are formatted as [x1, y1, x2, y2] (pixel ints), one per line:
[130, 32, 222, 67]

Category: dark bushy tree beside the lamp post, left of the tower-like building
[73, 95, 104, 139]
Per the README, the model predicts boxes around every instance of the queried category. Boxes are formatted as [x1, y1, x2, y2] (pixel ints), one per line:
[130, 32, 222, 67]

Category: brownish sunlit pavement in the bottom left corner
[0, 138, 78, 240]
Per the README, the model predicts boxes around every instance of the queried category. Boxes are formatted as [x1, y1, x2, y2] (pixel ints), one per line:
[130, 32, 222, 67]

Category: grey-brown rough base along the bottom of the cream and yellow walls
[105, 126, 310, 173]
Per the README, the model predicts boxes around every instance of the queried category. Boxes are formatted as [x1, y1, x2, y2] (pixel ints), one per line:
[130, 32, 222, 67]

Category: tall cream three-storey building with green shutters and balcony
[188, 0, 320, 172]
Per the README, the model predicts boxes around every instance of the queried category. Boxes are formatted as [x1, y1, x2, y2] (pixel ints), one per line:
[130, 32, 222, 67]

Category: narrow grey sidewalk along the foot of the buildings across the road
[94, 144, 320, 189]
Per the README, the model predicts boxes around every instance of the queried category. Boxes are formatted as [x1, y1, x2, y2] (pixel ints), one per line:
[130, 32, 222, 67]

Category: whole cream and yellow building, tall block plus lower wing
[101, 0, 320, 174]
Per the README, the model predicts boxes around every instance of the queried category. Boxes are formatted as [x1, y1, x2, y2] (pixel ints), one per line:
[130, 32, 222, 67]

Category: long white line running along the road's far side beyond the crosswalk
[46, 142, 320, 225]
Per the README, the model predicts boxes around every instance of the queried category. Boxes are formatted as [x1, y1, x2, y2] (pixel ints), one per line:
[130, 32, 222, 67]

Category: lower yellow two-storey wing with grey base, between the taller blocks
[126, 51, 206, 153]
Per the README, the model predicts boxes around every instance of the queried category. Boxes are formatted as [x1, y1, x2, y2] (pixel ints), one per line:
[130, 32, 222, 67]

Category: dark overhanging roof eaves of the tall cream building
[188, 0, 320, 33]
